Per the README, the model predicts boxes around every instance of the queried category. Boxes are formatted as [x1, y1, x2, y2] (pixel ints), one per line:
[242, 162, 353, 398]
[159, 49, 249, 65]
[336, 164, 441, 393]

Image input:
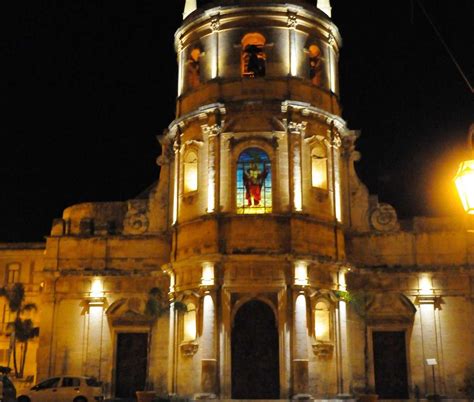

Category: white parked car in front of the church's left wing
[17, 375, 104, 402]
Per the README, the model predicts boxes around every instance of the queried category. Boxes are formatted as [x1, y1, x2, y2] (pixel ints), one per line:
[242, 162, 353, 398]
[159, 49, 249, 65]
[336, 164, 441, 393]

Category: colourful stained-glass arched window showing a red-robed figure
[237, 148, 272, 214]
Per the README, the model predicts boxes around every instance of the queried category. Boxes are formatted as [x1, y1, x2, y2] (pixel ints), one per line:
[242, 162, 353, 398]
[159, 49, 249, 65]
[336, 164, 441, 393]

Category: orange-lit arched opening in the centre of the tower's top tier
[241, 32, 266, 78]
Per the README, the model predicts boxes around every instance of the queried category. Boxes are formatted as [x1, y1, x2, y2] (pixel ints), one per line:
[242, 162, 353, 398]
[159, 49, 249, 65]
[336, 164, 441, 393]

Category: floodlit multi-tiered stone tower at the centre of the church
[159, 0, 355, 399]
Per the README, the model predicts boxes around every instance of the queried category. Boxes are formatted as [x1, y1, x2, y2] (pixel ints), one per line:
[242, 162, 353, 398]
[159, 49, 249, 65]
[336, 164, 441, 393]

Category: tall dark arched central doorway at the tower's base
[231, 300, 280, 399]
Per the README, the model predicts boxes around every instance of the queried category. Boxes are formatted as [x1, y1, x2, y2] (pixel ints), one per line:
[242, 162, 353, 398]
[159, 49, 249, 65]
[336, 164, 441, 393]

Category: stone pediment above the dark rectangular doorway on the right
[367, 293, 416, 323]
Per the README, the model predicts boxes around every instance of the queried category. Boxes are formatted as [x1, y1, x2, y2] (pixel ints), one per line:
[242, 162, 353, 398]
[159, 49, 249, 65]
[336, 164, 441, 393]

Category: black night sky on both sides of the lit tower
[0, 0, 474, 241]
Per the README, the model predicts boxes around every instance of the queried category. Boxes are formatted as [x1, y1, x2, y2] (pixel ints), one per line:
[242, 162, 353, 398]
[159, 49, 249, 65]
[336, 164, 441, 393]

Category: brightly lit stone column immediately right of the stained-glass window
[288, 121, 307, 212]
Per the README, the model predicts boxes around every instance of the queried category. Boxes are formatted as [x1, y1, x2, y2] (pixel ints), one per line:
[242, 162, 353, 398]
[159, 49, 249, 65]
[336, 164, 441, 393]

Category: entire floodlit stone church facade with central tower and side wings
[0, 0, 474, 399]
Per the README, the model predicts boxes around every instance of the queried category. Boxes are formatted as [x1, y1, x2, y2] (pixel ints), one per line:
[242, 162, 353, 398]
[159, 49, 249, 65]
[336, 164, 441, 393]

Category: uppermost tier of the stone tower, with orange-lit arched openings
[175, 0, 341, 118]
